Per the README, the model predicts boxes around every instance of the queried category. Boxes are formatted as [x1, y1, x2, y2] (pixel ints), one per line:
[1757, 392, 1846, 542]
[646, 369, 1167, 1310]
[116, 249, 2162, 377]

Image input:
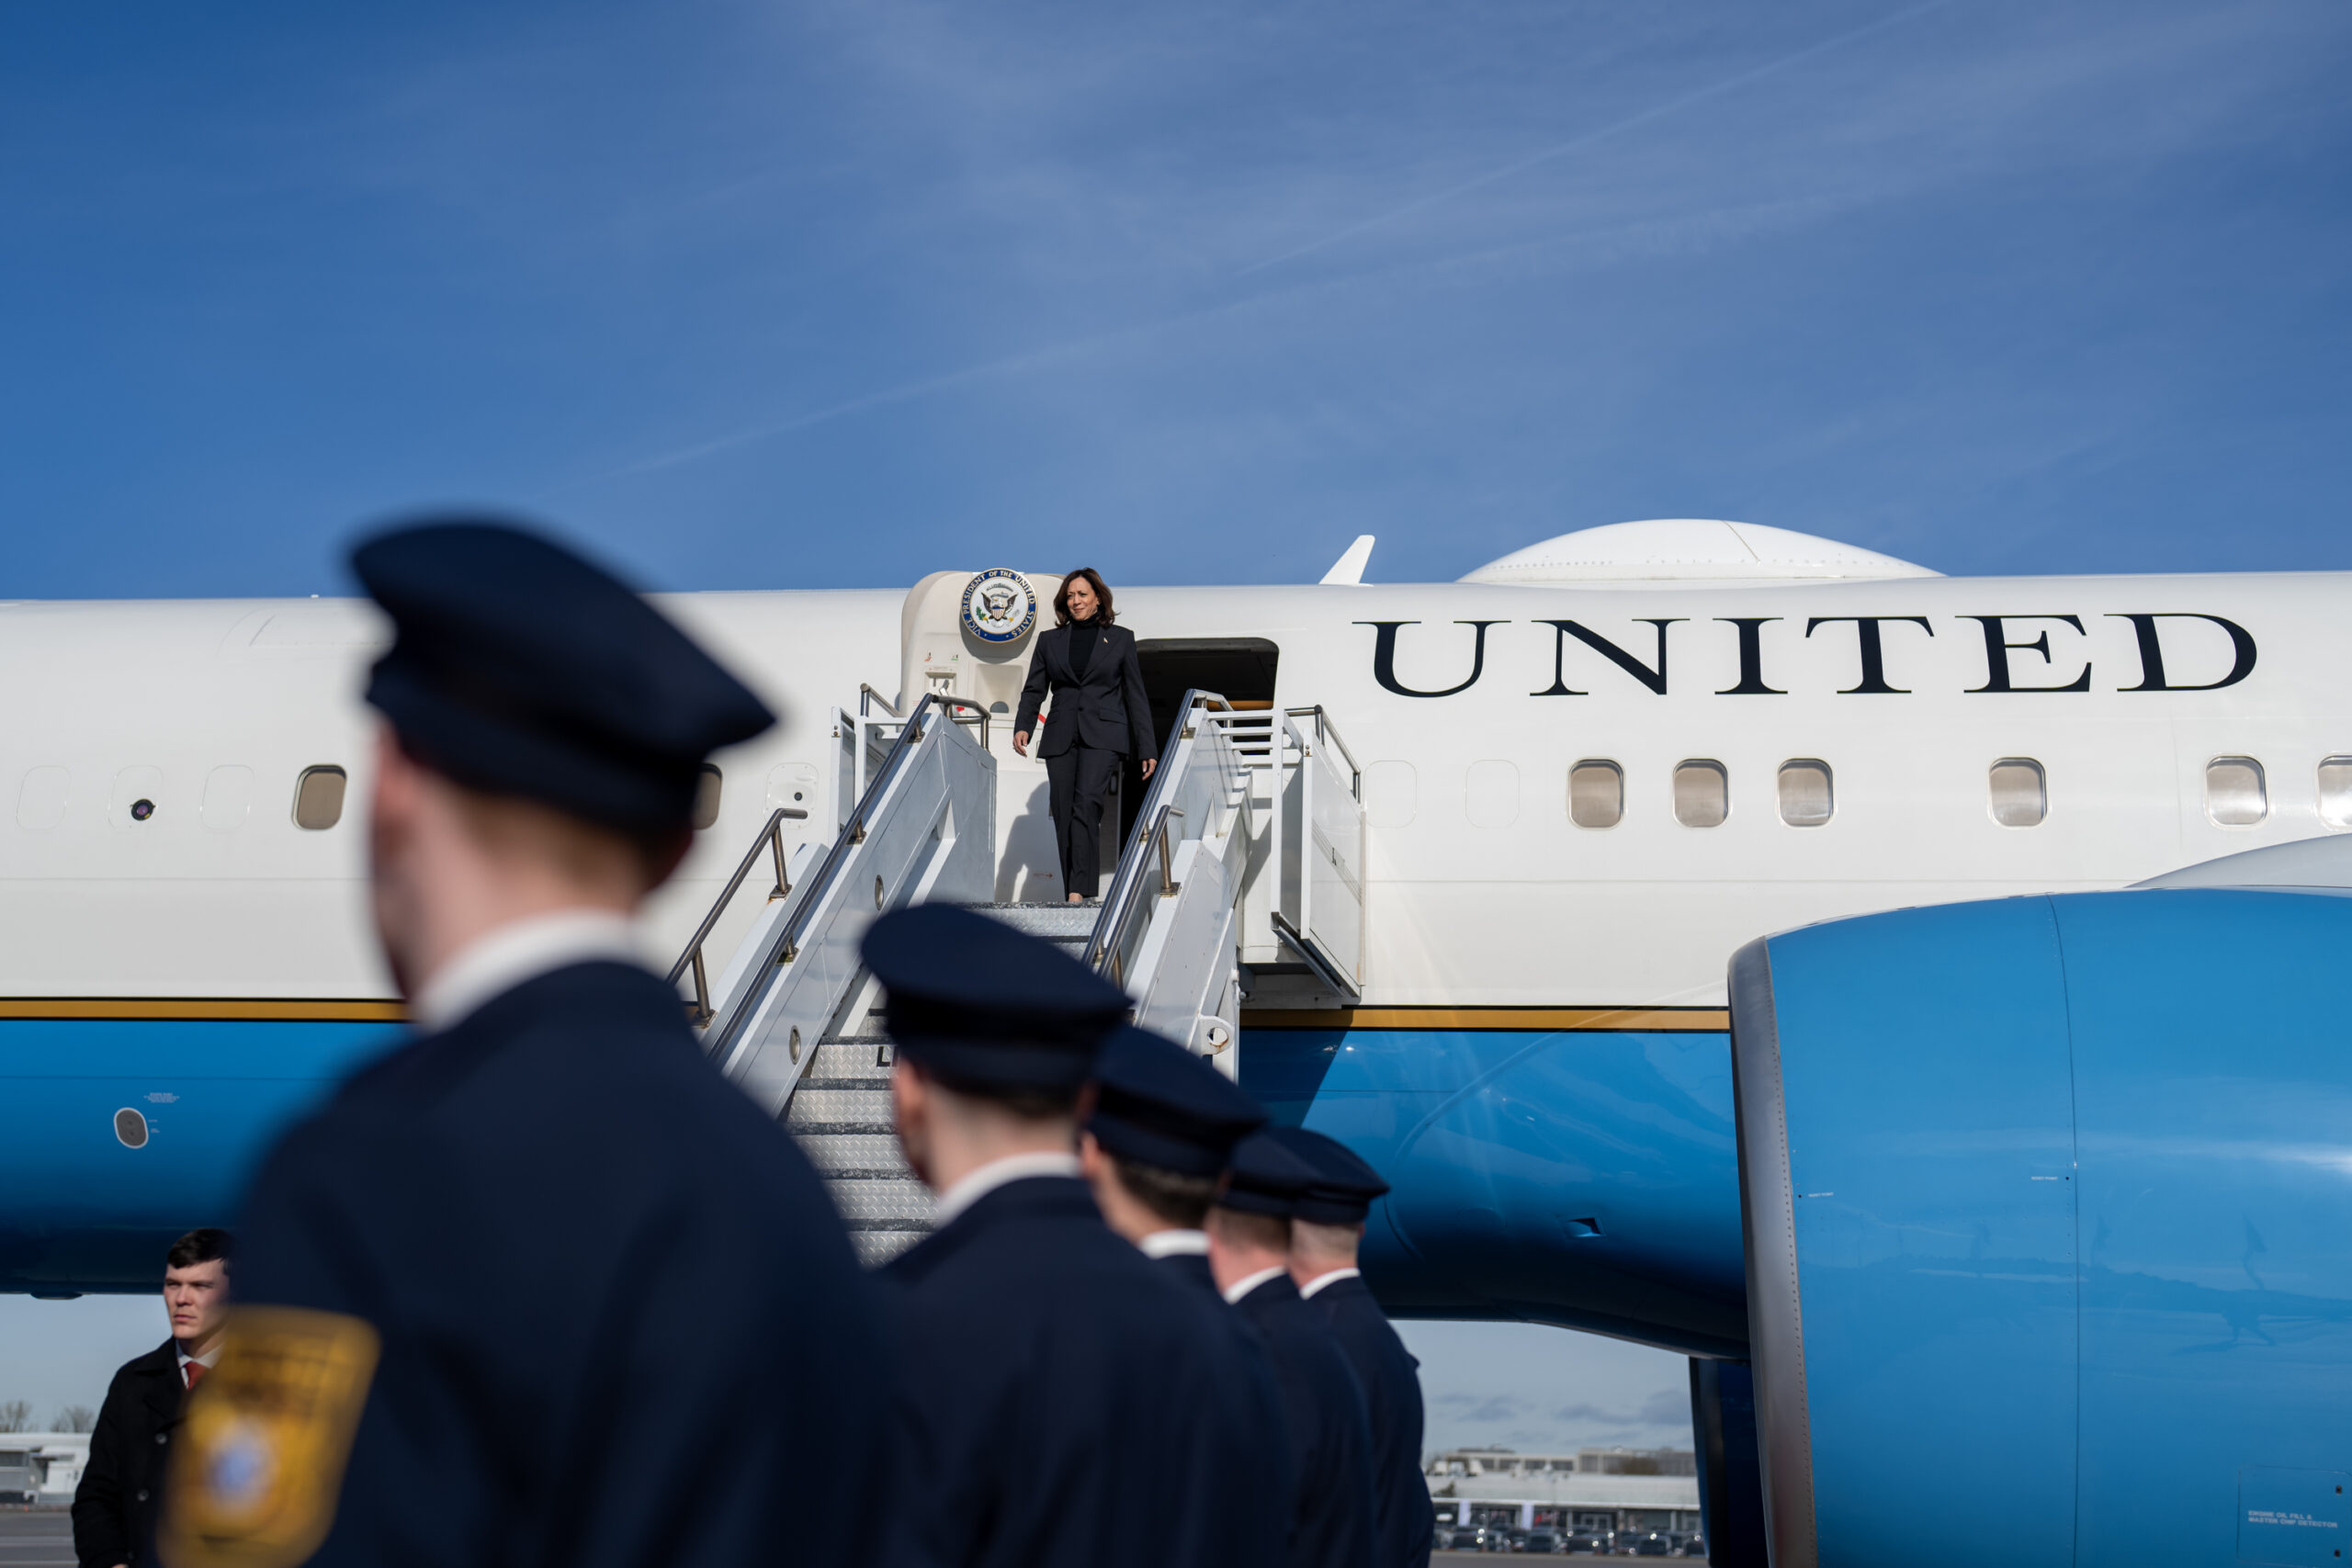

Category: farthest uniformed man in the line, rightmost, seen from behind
[1272, 1126, 1435, 1568]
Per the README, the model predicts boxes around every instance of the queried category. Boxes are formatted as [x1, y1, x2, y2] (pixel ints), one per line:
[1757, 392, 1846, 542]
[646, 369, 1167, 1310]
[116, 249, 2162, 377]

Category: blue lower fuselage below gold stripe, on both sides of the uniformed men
[0, 1021, 1746, 1357]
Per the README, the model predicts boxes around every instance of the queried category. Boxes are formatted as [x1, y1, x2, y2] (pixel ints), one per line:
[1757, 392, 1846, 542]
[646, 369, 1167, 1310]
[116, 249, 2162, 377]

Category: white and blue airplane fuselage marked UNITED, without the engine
[0, 520, 2352, 1561]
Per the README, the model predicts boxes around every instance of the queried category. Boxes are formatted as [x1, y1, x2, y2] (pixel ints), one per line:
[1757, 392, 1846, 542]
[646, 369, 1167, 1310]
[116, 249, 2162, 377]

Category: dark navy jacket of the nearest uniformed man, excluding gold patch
[221, 964, 889, 1568]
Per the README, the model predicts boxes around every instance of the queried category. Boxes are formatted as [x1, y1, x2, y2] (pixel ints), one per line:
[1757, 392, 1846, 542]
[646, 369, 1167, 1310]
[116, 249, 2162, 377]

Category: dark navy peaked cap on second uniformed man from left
[864, 903, 1126, 1096]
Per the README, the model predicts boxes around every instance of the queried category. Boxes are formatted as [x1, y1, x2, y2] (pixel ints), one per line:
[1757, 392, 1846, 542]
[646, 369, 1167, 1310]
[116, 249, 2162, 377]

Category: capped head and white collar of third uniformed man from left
[1077, 1025, 1265, 1293]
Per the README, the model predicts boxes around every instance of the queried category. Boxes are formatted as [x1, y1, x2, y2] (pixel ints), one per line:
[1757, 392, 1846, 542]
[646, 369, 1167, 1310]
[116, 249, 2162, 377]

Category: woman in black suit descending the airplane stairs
[1013, 567, 1159, 903]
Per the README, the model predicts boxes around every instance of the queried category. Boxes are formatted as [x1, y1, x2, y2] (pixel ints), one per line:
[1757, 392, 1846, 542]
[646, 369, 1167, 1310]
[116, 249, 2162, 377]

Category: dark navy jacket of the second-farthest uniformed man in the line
[1235, 1274, 1374, 1568]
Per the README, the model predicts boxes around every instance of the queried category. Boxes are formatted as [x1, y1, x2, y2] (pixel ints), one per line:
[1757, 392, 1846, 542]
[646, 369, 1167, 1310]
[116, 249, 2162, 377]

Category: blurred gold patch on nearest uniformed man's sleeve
[163, 1307, 379, 1568]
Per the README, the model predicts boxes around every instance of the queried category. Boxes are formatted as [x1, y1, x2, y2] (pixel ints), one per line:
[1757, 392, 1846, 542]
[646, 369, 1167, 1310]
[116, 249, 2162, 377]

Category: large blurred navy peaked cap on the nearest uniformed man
[350, 517, 776, 832]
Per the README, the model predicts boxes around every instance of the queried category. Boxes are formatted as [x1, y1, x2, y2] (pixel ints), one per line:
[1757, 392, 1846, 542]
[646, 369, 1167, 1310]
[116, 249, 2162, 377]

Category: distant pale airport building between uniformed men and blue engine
[1423, 1448, 1698, 1538]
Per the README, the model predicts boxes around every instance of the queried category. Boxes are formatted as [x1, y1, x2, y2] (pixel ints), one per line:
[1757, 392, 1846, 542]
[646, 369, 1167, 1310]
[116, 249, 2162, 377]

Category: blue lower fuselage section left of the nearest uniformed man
[0, 1018, 402, 1293]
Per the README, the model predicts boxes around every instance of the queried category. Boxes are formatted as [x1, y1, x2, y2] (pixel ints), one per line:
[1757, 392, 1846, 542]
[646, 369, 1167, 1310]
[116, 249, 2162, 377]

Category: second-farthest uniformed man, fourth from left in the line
[1209, 1131, 1374, 1568]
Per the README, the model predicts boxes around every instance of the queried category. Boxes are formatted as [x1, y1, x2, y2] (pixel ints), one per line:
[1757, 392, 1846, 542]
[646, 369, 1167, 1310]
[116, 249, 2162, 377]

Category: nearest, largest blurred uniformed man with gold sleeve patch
[163, 522, 889, 1568]
